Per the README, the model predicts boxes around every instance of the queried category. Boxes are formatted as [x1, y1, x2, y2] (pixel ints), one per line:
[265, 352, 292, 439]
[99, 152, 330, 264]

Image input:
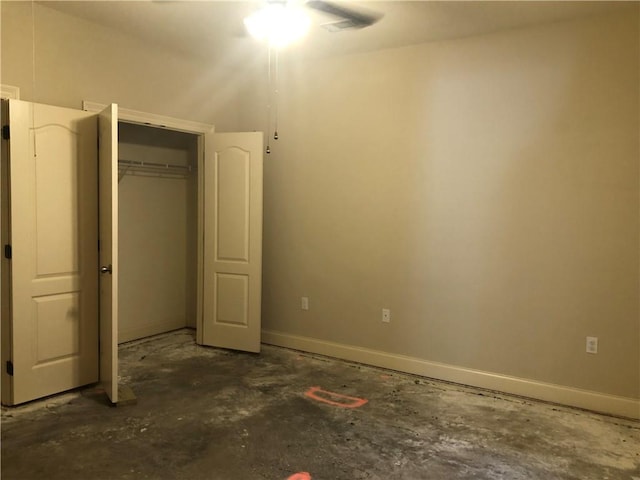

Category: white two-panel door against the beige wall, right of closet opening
[205, 132, 262, 352]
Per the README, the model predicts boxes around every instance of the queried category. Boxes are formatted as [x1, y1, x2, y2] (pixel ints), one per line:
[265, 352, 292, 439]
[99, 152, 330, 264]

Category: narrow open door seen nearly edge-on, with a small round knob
[98, 104, 118, 403]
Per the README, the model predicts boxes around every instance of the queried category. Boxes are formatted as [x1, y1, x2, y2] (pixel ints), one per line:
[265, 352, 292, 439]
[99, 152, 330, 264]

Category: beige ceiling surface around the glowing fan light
[41, 0, 635, 60]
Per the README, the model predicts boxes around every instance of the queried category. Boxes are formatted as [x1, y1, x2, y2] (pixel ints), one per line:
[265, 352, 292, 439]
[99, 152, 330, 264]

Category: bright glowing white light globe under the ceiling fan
[244, 1, 311, 47]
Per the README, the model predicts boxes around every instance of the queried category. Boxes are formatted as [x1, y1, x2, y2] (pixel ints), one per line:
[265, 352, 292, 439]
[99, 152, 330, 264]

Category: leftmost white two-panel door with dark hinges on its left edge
[3, 100, 98, 405]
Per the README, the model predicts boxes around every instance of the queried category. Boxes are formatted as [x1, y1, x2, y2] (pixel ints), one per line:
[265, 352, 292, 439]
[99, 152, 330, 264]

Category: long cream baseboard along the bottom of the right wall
[262, 330, 640, 419]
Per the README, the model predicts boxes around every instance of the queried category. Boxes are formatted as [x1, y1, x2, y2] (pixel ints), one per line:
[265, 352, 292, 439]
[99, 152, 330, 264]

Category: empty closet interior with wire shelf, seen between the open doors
[118, 122, 198, 343]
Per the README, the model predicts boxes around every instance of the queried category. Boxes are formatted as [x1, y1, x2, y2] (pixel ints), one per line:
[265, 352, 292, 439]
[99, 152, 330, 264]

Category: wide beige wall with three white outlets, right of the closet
[241, 11, 640, 398]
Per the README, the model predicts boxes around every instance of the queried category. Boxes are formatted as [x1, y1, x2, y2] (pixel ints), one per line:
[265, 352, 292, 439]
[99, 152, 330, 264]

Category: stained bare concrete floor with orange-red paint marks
[1, 330, 640, 480]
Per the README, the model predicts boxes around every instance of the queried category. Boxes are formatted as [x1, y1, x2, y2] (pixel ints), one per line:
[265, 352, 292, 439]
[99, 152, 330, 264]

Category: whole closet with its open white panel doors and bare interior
[0, 99, 263, 405]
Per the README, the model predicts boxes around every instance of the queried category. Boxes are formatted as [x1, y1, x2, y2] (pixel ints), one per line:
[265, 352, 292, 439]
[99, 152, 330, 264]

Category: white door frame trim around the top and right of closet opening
[82, 100, 215, 344]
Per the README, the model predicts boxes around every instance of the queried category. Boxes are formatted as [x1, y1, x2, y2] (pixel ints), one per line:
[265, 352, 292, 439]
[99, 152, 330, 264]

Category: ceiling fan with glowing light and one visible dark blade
[244, 0, 382, 46]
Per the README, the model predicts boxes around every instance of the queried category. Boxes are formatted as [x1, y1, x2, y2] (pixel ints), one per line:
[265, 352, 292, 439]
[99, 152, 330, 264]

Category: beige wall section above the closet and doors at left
[0, 1, 251, 131]
